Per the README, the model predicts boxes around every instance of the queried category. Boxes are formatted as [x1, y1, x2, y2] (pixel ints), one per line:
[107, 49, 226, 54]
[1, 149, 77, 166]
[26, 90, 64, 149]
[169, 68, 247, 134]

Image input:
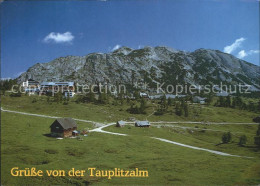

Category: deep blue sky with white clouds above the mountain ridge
[1, 0, 259, 78]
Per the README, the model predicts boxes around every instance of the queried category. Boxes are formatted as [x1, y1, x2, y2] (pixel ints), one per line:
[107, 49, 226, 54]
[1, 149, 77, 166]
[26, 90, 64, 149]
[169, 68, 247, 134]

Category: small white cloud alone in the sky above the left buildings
[43, 32, 74, 43]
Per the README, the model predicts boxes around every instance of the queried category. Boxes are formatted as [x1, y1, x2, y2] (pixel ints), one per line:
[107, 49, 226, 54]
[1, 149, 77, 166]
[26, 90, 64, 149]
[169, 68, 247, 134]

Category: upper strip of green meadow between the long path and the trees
[2, 95, 259, 122]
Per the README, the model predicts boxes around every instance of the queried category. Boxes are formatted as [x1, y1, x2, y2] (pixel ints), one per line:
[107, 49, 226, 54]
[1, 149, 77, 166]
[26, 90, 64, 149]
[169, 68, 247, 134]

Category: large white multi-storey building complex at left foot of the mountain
[22, 79, 75, 97]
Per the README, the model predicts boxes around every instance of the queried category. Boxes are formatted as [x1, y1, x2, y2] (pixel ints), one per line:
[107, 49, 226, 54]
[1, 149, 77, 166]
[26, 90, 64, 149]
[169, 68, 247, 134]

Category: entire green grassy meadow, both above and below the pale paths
[1, 95, 260, 185]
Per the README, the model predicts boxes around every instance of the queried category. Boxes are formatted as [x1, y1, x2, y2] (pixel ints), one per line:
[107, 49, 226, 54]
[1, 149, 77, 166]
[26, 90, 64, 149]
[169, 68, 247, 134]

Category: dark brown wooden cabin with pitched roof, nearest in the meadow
[50, 118, 77, 137]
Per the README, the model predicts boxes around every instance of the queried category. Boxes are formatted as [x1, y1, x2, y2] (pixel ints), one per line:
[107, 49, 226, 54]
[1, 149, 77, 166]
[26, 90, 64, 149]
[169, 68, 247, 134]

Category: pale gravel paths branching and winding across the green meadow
[1, 108, 254, 158]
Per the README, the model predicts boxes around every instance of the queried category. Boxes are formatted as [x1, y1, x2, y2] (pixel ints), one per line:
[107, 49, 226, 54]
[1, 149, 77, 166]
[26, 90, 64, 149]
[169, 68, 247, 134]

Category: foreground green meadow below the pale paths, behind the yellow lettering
[1, 112, 260, 185]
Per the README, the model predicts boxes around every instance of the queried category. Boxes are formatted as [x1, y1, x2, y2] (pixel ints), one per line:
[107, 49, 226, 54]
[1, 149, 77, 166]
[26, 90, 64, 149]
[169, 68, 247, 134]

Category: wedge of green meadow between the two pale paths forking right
[104, 124, 260, 157]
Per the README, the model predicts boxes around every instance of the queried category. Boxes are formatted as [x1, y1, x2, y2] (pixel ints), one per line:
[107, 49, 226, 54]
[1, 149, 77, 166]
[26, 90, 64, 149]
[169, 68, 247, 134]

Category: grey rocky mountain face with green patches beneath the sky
[18, 47, 260, 89]
